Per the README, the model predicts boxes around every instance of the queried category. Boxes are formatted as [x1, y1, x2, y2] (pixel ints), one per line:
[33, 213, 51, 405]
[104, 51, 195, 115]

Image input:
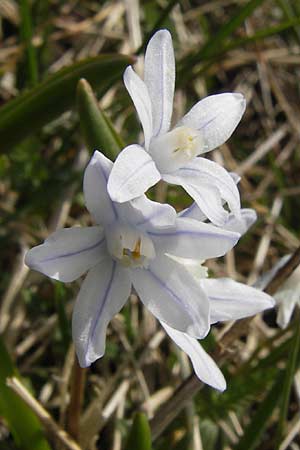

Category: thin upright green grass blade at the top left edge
[20, 0, 38, 86]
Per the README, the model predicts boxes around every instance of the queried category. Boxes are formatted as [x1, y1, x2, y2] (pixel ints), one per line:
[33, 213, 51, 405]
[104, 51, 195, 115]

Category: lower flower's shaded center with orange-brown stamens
[105, 223, 155, 268]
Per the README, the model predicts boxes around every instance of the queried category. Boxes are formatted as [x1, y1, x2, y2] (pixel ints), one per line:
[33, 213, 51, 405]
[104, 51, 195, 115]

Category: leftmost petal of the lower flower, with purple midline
[25, 227, 107, 282]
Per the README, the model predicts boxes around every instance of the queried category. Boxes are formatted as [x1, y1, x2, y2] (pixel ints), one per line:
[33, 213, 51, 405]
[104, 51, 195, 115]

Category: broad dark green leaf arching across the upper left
[0, 55, 132, 152]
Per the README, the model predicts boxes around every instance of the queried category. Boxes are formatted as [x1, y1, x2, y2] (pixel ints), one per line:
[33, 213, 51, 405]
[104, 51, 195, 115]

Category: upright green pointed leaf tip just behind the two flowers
[77, 79, 125, 159]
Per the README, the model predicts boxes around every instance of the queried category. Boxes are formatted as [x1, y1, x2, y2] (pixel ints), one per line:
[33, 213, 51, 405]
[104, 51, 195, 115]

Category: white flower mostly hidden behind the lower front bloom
[165, 208, 275, 391]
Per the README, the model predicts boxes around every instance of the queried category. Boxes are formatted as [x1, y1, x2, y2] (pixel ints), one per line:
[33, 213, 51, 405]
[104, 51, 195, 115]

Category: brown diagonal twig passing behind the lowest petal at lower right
[150, 247, 300, 439]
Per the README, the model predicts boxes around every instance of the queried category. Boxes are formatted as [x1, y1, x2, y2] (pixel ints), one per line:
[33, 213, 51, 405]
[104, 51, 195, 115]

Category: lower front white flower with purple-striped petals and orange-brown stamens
[25, 151, 240, 367]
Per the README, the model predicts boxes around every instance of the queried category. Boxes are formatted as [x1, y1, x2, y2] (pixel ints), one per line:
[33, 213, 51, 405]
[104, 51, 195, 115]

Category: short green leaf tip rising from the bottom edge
[125, 412, 152, 450]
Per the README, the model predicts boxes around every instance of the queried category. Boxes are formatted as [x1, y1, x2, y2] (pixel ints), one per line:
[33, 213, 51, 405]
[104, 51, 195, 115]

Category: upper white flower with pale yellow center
[108, 30, 246, 226]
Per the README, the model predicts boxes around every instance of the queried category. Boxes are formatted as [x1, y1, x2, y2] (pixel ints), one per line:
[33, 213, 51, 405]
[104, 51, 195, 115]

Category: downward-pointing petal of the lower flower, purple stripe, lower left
[72, 258, 131, 367]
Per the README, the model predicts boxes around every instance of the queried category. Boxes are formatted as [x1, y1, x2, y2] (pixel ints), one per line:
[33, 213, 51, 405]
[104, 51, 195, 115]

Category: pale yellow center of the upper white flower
[149, 126, 204, 173]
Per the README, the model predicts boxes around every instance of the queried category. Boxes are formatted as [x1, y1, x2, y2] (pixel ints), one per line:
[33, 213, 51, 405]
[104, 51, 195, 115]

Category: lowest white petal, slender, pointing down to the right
[160, 321, 226, 392]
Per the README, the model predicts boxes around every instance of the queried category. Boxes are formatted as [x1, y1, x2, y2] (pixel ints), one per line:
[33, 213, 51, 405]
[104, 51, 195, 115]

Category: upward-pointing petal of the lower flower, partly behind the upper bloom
[83, 150, 117, 225]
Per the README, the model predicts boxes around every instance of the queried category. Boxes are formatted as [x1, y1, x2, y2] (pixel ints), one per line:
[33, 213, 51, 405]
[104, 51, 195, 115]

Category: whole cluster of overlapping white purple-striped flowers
[26, 30, 274, 391]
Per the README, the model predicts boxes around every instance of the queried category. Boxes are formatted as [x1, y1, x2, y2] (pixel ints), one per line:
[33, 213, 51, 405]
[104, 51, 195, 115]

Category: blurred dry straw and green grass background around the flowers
[0, 0, 300, 450]
